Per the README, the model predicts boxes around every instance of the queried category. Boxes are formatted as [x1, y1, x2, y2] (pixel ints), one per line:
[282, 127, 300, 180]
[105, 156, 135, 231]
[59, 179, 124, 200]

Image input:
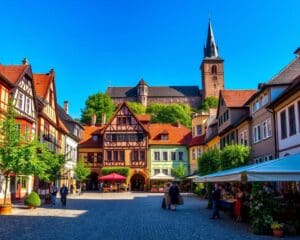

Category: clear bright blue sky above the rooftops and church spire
[0, 0, 300, 117]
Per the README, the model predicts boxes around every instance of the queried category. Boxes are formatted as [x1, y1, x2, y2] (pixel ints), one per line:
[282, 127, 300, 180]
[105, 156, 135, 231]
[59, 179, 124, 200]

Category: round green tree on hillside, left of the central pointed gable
[81, 92, 116, 124]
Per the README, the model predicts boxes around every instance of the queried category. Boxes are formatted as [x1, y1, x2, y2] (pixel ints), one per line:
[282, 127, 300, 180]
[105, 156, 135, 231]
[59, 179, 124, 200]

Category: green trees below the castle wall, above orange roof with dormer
[146, 103, 191, 127]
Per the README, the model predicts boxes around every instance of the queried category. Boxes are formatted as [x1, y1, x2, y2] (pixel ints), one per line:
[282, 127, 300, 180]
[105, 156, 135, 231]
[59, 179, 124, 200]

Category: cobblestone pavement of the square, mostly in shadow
[0, 193, 300, 240]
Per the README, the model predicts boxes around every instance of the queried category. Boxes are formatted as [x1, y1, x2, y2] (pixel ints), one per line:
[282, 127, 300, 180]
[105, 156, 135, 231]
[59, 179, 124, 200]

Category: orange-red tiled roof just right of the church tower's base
[220, 90, 257, 108]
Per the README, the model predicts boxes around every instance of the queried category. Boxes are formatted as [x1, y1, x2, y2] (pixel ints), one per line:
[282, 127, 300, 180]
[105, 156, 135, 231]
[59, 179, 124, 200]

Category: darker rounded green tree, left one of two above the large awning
[198, 149, 220, 176]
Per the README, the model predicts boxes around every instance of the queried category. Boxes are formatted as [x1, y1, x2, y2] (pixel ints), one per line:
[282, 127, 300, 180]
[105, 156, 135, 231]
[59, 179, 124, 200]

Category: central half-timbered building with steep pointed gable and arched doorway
[102, 102, 149, 190]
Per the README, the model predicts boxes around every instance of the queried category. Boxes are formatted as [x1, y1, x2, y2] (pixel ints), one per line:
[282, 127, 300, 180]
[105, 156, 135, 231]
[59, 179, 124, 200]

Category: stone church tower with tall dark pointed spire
[201, 21, 224, 99]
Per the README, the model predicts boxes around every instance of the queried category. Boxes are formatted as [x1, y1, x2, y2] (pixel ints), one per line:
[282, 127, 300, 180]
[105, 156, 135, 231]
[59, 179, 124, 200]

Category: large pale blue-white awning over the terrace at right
[193, 153, 300, 182]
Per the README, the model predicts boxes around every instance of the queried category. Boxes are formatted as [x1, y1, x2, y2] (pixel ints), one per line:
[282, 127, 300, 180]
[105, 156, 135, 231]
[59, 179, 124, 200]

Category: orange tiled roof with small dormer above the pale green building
[149, 123, 192, 145]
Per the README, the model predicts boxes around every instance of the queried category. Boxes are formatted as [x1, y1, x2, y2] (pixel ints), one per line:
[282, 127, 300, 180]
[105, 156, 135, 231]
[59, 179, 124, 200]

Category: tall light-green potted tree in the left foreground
[0, 102, 48, 204]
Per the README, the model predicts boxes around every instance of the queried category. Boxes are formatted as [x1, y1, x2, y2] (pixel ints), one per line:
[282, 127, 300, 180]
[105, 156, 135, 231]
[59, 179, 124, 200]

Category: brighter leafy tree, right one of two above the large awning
[221, 144, 250, 170]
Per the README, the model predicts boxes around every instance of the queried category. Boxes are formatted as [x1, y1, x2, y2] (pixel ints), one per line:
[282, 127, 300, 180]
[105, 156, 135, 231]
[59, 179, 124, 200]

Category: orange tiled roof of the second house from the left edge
[33, 72, 54, 99]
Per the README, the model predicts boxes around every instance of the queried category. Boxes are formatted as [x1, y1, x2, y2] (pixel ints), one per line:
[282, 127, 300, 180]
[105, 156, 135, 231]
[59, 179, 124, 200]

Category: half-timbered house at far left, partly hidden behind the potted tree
[0, 59, 37, 200]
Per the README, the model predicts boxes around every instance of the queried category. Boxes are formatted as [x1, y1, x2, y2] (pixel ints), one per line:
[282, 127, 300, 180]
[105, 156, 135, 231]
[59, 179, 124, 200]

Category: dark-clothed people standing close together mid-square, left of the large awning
[162, 182, 180, 211]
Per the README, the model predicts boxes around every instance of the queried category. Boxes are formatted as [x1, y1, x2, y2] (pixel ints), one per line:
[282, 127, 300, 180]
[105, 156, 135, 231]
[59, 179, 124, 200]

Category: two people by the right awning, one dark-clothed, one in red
[211, 184, 244, 222]
